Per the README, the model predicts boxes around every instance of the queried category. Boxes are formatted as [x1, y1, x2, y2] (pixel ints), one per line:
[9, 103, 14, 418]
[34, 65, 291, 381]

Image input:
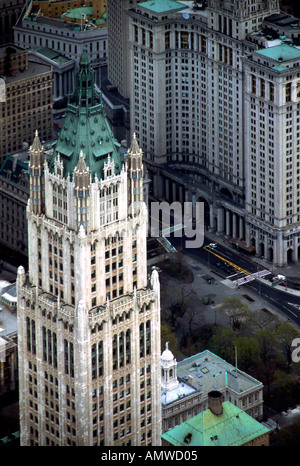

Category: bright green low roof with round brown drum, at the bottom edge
[162, 401, 269, 447]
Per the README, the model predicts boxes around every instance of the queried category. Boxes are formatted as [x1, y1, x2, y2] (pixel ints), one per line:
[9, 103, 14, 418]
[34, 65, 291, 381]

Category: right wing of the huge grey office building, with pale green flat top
[244, 43, 300, 263]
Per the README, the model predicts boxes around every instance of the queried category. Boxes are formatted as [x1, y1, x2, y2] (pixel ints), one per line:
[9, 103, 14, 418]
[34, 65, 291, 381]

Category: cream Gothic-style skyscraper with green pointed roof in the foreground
[17, 52, 161, 446]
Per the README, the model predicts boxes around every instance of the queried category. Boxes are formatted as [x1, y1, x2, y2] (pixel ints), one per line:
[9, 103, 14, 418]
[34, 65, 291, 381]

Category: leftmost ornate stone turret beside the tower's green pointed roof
[28, 131, 45, 214]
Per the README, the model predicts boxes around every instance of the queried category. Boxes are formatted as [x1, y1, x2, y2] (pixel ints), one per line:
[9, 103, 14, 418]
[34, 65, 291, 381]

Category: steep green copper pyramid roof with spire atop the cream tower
[49, 51, 122, 179]
